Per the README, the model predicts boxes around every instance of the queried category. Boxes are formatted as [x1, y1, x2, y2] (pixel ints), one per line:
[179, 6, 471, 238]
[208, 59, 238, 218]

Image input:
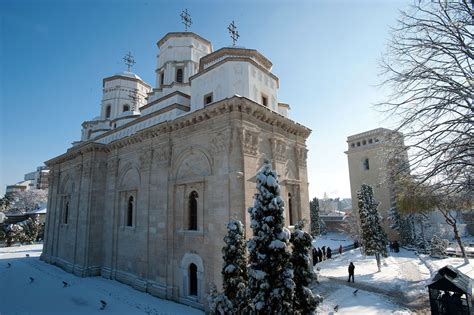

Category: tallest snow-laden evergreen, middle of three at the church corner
[248, 160, 295, 314]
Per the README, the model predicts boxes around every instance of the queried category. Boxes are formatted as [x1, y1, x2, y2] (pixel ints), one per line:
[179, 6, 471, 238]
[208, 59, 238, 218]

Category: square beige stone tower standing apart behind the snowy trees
[345, 128, 408, 239]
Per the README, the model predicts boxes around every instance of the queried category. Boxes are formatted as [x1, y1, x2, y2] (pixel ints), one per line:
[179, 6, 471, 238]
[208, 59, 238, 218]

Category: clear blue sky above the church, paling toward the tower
[0, 0, 411, 198]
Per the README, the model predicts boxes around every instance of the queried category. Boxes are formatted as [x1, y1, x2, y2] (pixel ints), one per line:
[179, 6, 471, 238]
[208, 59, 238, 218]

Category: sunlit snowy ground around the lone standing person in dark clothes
[315, 249, 474, 314]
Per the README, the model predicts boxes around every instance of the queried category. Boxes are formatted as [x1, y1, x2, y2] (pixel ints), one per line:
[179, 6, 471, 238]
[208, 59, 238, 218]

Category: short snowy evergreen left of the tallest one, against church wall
[222, 220, 248, 314]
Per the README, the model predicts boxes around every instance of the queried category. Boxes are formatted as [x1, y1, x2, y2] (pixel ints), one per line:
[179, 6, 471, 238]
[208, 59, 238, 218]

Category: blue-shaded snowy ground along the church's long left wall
[0, 245, 203, 315]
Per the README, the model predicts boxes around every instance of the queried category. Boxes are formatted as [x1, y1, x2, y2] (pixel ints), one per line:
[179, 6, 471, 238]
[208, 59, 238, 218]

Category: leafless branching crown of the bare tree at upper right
[379, 0, 474, 195]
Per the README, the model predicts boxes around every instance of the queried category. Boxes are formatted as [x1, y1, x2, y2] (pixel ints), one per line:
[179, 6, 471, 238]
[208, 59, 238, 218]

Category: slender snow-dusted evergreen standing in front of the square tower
[357, 184, 388, 271]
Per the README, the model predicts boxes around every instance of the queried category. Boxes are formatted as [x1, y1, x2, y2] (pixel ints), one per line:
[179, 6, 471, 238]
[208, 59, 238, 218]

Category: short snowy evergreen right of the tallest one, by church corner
[290, 222, 322, 314]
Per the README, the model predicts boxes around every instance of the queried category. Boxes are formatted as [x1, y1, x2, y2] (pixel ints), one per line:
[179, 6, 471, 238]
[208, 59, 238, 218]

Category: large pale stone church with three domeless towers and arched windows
[41, 32, 311, 308]
